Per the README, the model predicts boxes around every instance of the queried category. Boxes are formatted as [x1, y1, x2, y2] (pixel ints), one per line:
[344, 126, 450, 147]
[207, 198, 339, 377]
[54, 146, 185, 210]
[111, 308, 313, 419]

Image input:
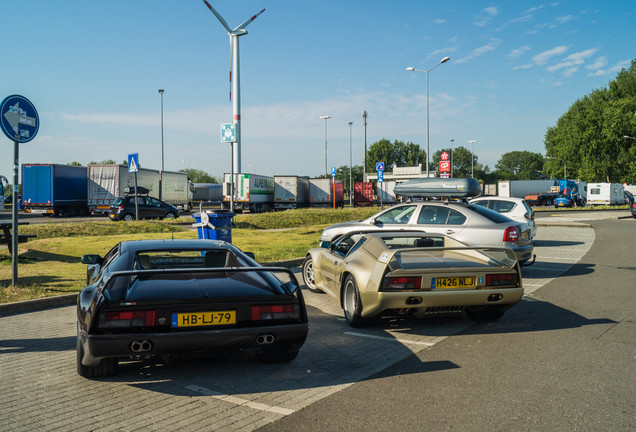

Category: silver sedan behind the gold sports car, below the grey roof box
[320, 201, 534, 264]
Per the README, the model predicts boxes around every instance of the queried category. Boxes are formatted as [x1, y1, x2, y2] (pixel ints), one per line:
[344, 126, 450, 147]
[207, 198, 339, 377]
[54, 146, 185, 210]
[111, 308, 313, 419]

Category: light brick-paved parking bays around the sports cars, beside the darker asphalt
[0, 220, 594, 431]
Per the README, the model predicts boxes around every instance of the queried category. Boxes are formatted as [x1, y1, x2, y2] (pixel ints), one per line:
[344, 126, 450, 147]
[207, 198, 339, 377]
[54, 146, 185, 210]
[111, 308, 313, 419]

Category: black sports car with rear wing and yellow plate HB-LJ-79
[77, 240, 308, 378]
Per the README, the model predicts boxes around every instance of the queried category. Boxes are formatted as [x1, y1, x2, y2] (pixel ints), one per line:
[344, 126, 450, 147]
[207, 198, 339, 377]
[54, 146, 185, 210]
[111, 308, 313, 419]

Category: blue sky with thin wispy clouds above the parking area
[0, 0, 636, 177]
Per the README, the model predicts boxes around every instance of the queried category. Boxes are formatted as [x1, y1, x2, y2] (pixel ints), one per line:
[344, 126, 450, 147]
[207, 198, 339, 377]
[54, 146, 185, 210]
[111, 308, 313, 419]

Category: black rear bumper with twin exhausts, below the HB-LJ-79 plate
[79, 322, 309, 366]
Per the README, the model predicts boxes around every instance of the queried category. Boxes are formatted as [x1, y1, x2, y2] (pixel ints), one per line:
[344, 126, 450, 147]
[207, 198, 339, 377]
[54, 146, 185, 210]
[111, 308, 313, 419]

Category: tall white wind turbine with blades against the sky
[203, 0, 265, 173]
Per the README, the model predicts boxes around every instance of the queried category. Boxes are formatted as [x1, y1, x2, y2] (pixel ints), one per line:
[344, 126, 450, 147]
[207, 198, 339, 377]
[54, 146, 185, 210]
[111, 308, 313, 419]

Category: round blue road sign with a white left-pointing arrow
[0, 95, 40, 143]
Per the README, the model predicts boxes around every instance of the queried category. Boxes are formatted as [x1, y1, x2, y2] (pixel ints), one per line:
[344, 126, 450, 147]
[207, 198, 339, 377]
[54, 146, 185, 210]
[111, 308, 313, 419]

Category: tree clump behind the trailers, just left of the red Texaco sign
[366, 138, 426, 173]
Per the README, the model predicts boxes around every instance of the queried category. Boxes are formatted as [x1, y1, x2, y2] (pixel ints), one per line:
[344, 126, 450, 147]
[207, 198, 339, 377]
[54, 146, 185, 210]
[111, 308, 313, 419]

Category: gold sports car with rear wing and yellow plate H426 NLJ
[303, 231, 523, 327]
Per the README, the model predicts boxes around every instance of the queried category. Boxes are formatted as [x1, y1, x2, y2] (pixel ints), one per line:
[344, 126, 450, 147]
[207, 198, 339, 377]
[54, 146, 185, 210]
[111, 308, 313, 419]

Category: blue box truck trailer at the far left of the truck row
[22, 164, 88, 216]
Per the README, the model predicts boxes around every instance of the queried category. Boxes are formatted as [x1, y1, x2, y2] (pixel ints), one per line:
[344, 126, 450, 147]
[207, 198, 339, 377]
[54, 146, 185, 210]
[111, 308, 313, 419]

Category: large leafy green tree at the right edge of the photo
[544, 60, 636, 183]
